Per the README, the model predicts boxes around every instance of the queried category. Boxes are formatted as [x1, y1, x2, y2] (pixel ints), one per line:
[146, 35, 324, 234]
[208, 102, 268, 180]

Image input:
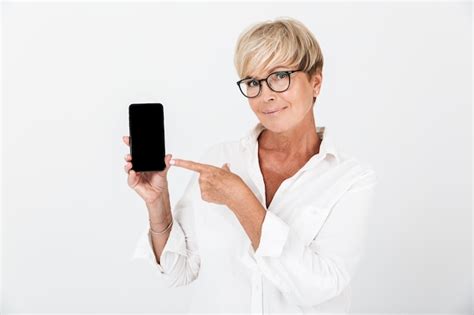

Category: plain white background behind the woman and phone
[1, 2, 473, 314]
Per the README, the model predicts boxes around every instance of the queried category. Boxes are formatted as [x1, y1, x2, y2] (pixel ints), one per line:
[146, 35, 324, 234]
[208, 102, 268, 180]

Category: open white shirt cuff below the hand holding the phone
[130, 218, 186, 274]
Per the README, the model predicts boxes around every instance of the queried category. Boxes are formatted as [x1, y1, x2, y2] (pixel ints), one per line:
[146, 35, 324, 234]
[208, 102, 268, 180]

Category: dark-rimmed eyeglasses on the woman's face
[237, 69, 303, 98]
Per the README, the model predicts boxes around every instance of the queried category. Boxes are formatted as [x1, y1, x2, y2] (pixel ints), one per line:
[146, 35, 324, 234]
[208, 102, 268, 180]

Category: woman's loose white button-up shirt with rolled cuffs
[132, 123, 377, 314]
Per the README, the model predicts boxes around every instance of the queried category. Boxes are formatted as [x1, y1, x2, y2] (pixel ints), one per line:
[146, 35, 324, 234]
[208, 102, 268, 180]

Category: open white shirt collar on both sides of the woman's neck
[240, 122, 340, 163]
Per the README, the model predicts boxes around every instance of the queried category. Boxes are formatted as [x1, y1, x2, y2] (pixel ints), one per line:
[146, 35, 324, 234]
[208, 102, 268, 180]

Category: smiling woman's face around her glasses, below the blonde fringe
[248, 66, 322, 132]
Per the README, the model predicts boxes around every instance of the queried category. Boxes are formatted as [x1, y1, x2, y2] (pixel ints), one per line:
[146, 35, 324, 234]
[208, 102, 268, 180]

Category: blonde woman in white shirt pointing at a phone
[124, 18, 376, 314]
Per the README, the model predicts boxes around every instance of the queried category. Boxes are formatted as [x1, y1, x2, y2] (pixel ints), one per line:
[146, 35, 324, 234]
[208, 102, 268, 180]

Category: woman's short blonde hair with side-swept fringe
[234, 17, 323, 78]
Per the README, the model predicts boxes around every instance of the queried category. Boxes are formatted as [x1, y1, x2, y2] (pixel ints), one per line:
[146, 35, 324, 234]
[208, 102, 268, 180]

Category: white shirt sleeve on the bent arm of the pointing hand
[255, 170, 377, 306]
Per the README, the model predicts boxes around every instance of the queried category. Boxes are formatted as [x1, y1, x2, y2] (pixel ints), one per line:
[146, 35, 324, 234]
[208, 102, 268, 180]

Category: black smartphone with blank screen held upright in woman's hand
[128, 103, 166, 172]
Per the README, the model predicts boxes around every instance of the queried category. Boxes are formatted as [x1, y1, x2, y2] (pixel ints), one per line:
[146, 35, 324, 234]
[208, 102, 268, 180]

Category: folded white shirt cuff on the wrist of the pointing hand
[255, 210, 290, 257]
